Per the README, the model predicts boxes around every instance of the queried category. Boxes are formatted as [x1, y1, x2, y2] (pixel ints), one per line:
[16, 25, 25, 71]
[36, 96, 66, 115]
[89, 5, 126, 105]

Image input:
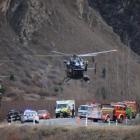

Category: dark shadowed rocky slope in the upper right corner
[89, 0, 140, 54]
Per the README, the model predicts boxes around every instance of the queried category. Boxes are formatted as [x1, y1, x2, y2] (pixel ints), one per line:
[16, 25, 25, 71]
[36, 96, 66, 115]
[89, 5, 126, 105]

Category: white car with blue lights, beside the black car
[21, 110, 39, 123]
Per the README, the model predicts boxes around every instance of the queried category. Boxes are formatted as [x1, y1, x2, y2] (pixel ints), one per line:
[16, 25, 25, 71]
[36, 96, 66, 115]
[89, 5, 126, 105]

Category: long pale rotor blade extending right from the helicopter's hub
[78, 50, 117, 57]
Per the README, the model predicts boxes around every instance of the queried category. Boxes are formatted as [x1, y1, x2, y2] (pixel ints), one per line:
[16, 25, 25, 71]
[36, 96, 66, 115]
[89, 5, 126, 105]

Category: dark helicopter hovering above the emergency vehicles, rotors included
[52, 50, 117, 83]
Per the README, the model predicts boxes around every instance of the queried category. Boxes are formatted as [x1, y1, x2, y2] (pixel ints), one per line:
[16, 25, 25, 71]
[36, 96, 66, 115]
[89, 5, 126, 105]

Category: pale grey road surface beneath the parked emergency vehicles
[1, 118, 136, 127]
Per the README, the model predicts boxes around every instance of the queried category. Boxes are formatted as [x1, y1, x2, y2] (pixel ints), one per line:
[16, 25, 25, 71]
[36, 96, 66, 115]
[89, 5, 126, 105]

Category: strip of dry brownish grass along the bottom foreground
[0, 125, 140, 140]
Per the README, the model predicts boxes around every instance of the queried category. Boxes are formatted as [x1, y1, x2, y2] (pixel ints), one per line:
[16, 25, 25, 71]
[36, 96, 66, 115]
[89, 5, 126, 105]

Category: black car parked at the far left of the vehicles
[6, 110, 21, 122]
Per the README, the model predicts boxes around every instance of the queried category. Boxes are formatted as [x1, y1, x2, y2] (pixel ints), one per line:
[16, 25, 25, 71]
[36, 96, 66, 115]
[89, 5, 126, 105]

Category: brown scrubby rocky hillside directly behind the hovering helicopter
[0, 0, 140, 101]
